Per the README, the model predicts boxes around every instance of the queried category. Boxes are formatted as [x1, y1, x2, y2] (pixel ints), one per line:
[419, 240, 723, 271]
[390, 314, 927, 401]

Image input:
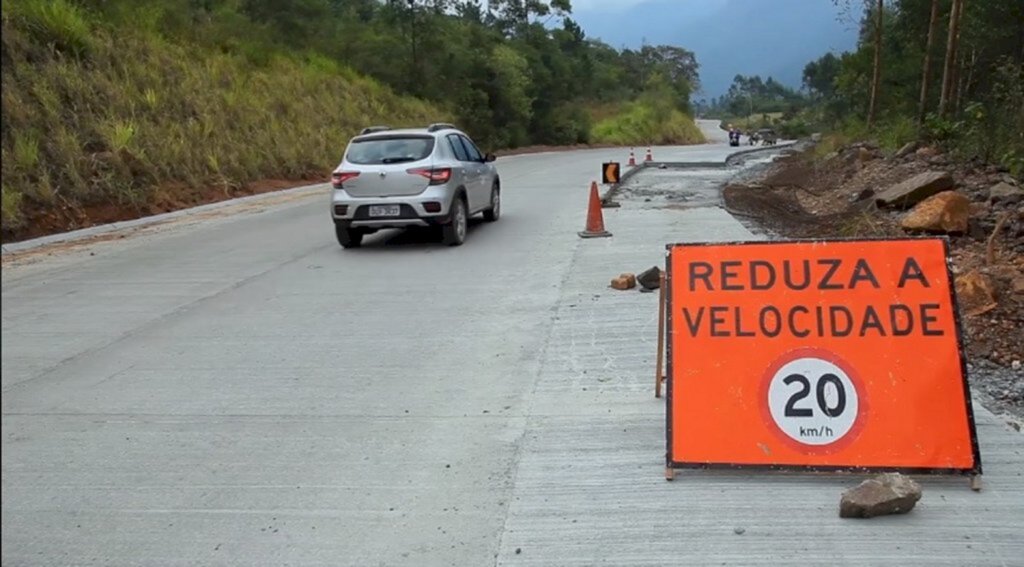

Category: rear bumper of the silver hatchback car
[331, 186, 452, 228]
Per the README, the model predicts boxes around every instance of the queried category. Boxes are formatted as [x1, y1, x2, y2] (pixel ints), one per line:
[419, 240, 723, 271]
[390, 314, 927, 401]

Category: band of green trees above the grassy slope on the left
[90, 0, 698, 148]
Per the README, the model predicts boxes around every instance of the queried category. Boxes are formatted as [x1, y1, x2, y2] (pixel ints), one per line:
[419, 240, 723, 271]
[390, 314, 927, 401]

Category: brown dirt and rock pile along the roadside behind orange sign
[723, 143, 1024, 412]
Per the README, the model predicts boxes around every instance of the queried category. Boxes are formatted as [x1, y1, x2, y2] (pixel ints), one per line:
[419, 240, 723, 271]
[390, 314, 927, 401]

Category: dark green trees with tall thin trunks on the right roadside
[697, 0, 1024, 178]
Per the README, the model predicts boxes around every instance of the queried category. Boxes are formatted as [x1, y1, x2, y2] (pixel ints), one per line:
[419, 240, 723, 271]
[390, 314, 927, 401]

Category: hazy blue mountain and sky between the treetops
[572, 0, 857, 97]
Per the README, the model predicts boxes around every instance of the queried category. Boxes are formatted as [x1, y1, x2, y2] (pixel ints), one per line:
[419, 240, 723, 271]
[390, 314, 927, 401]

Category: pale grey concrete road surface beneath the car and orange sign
[2, 124, 1024, 566]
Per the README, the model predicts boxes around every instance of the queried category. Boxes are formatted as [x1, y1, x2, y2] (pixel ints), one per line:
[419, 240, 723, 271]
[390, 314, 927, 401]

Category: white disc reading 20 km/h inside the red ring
[768, 356, 860, 446]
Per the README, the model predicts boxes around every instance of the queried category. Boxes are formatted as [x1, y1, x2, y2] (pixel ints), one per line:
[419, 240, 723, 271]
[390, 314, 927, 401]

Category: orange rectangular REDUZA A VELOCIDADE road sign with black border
[667, 238, 981, 474]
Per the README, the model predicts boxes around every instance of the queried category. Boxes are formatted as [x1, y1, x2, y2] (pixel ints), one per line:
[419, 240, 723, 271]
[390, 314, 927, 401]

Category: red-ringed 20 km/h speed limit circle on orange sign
[762, 349, 866, 451]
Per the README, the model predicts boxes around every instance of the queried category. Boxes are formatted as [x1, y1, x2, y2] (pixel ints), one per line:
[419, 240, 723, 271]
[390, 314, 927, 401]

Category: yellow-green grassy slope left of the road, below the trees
[0, 0, 451, 239]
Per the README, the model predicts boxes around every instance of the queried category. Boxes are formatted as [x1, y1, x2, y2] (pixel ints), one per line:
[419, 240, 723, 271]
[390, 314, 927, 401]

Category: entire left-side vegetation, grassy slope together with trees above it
[0, 0, 699, 237]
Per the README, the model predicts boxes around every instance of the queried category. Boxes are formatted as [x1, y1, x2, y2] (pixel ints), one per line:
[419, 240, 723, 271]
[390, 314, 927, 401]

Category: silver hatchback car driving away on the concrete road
[331, 124, 502, 248]
